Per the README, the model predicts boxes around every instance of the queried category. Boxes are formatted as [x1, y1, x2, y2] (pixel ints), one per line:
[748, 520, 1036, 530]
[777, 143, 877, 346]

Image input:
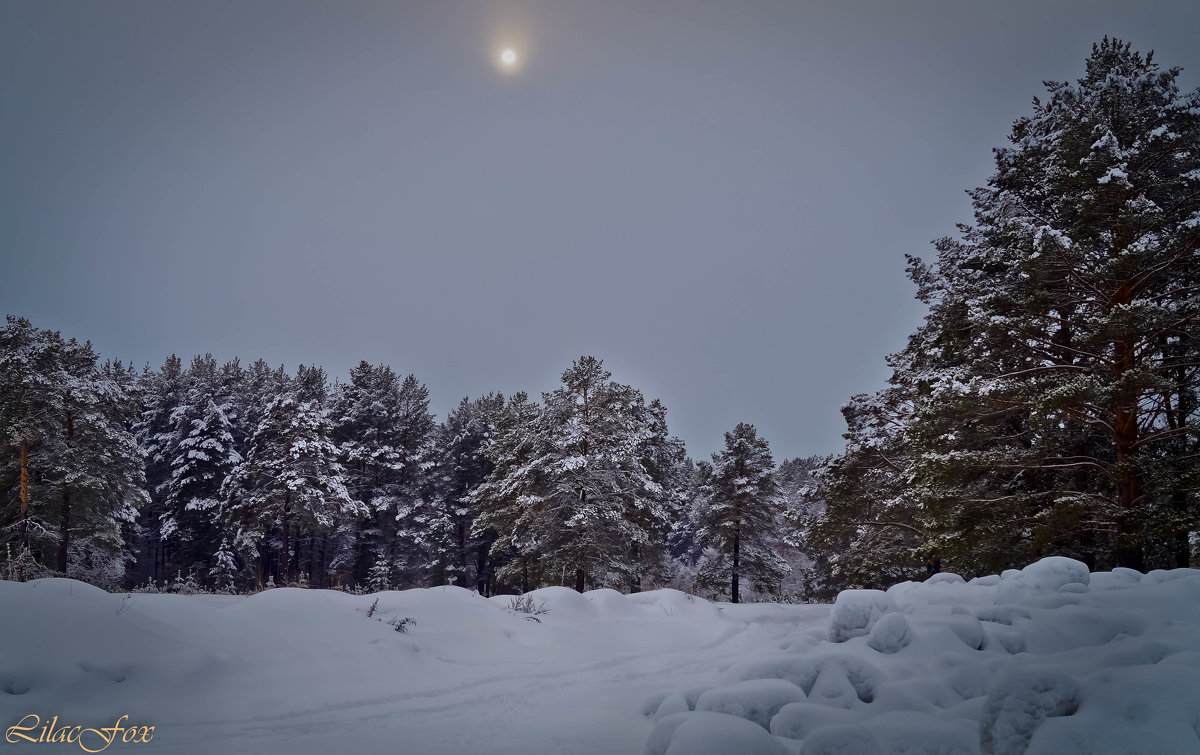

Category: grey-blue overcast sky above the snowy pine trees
[0, 0, 1200, 459]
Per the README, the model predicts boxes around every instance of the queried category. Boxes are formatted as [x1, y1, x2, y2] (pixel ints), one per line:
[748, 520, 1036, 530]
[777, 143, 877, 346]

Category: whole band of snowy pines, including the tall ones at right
[0, 38, 1200, 599]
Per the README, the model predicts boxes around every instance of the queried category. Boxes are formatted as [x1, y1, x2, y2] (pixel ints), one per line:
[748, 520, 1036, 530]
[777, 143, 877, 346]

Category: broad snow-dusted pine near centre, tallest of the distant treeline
[470, 356, 667, 592]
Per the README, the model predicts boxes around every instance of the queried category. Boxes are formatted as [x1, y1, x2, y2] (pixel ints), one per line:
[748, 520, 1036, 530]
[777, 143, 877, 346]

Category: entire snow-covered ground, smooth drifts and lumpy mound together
[0, 558, 1200, 755]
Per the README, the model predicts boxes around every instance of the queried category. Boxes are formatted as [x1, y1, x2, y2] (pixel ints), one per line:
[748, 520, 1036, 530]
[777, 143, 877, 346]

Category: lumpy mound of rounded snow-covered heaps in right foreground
[646, 557, 1200, 755]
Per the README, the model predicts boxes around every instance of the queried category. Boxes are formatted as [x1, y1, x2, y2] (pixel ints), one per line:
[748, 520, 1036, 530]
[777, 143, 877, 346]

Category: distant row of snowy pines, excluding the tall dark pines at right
[0, 326, 803, 597]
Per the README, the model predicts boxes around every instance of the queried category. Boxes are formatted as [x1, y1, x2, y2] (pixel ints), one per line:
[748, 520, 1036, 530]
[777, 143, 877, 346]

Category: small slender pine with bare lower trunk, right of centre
[698, 423, 787, 603]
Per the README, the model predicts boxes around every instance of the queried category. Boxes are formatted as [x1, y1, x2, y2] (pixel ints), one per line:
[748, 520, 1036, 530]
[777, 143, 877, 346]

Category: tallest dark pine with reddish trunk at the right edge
[910, 38, 1200, 568]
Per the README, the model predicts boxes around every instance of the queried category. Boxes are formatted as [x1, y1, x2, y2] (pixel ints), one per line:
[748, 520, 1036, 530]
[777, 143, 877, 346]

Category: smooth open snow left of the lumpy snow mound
[0, 580, 828, 755]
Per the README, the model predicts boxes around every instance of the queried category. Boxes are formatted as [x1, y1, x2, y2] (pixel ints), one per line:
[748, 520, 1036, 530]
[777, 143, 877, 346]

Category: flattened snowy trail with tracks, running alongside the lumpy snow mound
[163, 607, 826, 755]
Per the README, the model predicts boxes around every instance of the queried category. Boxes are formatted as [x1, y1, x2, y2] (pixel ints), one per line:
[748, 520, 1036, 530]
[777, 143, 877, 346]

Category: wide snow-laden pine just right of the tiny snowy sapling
[221, 367, 362, 583]
